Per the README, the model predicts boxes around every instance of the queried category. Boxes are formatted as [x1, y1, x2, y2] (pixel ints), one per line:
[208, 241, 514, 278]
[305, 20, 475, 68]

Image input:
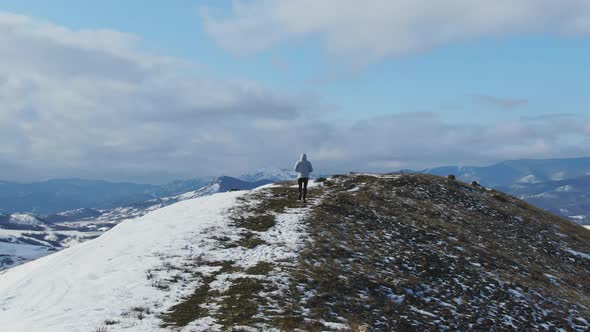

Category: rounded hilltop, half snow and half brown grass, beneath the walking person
[0, 174, 590, 331]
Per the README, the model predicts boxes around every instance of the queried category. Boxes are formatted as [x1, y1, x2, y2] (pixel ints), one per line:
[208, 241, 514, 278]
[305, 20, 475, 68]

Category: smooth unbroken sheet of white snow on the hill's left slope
[0, 192, 244, 332]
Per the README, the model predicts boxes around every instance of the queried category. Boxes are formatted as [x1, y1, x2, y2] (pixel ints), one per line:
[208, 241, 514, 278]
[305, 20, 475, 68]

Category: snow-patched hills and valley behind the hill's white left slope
[0, 176, 269, 270]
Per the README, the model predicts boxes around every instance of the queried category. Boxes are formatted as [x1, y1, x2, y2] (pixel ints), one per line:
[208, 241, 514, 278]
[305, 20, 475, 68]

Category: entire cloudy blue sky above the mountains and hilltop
[0, 0, 590, 183]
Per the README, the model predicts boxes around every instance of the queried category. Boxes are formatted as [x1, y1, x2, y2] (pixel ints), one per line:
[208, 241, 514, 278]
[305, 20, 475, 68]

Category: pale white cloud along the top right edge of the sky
[202, 0, 590, 65]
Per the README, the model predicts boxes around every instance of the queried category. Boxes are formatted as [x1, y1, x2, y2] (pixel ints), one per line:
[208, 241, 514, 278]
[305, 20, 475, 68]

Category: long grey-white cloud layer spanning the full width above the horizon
[0, 14, 590, 181]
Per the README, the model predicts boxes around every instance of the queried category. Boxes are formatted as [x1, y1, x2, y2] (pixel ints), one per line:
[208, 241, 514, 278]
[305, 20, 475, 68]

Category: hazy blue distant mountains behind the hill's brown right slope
[419, 157, 590, 187]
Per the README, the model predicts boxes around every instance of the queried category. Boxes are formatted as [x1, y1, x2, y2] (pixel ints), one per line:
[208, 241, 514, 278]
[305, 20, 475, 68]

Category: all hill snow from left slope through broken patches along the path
[0, 182, 316, 332]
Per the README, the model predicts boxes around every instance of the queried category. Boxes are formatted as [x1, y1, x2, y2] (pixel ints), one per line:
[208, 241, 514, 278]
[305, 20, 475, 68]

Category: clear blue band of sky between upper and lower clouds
[5, 0, 590, 121]
